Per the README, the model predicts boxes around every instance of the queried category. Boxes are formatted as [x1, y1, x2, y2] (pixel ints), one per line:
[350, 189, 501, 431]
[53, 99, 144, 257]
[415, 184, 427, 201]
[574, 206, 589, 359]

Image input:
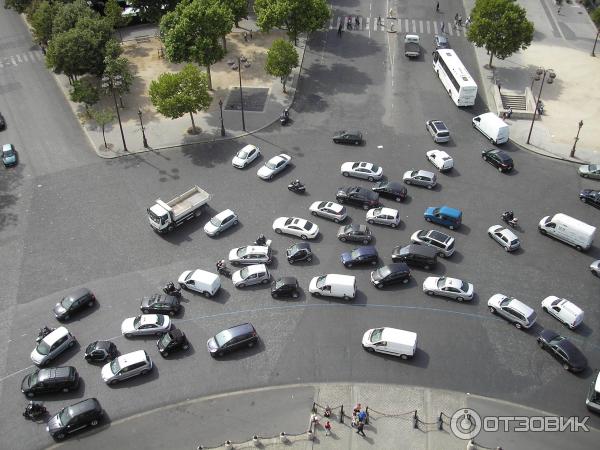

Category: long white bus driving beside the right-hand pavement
[433, 48, 477, 106]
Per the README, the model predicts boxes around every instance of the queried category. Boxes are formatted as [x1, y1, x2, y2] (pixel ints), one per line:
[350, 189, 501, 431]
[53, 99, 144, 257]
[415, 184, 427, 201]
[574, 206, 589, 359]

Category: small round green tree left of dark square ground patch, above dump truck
[149, 64, 212, 133]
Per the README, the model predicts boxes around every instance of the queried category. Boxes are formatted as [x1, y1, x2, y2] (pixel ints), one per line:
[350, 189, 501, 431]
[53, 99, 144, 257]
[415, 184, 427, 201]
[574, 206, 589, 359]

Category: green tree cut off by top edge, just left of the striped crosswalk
[254, 0, 330, 44]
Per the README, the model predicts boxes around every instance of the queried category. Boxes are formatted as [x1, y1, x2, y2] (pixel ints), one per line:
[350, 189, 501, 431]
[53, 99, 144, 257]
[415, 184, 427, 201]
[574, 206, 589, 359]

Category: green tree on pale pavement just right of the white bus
[467, 0, 534, 67]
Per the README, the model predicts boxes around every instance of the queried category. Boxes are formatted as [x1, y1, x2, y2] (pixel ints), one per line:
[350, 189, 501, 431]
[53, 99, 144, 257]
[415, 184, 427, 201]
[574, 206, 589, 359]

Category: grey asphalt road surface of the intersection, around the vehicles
[0, 2, 600, 448]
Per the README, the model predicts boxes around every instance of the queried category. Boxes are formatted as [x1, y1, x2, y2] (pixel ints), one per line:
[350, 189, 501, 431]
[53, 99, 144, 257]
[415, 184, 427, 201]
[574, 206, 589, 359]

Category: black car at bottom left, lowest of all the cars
[46, 398, 103, 440]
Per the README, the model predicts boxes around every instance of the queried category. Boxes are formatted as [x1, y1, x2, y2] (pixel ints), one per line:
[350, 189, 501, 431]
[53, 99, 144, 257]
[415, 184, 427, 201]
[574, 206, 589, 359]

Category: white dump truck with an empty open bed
[147, 186, 211, 234]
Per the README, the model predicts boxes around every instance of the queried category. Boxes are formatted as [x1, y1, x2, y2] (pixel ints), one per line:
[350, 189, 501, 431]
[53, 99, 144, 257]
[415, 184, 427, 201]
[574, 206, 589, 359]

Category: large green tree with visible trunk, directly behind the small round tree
[160, 0, 233, 89]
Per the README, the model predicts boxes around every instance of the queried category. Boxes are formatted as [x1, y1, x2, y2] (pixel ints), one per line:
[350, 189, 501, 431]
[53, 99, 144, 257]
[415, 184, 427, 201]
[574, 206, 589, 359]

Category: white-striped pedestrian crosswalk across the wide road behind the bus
[329, 16, 467, 36]
